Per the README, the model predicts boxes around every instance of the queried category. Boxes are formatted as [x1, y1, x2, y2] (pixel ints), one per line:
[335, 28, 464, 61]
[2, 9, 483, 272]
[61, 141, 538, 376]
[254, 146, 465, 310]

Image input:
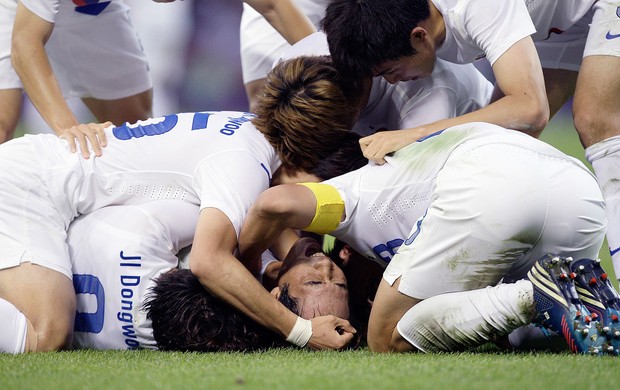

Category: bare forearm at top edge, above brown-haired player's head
[245, 0, 316, 45]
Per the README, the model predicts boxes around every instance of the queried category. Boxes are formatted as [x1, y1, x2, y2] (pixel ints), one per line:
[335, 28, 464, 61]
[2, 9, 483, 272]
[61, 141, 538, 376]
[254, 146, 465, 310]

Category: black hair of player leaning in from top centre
[321, 0, 430, 83]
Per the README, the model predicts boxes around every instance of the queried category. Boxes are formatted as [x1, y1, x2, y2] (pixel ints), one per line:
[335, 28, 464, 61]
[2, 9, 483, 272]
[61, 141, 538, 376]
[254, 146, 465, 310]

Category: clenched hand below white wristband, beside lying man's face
[306, 315, 357, 349]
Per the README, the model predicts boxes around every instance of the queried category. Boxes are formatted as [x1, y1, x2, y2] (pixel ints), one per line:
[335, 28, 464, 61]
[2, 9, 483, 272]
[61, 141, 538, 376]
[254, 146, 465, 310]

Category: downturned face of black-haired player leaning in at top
[374, 50, 436, 84]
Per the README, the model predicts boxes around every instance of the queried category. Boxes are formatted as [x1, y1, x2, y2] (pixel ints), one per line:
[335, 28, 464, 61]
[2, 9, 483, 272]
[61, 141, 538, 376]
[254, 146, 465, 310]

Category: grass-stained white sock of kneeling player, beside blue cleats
[396, 280, 535, 352]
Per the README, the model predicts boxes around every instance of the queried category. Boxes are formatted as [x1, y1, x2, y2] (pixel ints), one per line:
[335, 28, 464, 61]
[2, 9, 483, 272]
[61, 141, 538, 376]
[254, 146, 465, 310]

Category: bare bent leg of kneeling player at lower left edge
[0, 263, 76, 352]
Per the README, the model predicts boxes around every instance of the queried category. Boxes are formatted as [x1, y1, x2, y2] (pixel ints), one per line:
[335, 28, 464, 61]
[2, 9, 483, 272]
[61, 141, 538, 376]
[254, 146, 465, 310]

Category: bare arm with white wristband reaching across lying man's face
[190, 208, 354, 349]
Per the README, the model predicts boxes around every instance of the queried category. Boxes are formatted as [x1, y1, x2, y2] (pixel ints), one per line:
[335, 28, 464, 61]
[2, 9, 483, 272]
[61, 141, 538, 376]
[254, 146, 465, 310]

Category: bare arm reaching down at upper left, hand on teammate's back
[11, 2, 110, 158]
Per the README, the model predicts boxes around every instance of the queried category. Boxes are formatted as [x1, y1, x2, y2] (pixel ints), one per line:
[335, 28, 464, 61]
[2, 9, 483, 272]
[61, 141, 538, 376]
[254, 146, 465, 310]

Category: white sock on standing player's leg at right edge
[586, 136, 620, 279]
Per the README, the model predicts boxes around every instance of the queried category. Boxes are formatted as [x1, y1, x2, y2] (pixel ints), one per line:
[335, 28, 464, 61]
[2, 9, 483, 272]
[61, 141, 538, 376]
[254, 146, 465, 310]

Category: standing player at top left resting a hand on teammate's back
[0, 0, 152, 154]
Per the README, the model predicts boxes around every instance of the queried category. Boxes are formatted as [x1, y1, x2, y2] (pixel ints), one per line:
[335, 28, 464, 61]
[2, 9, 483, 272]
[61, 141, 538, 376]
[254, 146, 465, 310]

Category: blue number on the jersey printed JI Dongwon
[73, 274, 105, 333]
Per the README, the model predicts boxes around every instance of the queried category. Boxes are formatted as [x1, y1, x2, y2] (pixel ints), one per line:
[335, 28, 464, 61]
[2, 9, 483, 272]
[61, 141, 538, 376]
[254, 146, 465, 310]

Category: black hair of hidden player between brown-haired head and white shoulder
[312, 132, 368, 180]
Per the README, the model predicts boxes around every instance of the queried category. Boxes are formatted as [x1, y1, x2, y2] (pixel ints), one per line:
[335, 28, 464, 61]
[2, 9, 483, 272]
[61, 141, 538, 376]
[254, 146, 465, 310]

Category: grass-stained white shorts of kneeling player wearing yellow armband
[384, 144, 606, 299]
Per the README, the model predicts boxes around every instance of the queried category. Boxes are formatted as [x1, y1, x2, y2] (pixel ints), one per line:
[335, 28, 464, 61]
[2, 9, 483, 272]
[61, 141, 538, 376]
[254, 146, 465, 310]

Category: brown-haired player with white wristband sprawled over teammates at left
[0, 58, 357, 351]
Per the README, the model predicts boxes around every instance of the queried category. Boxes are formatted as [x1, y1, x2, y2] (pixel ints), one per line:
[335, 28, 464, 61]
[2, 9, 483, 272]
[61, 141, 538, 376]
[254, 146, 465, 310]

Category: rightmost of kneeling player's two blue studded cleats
[570, 259, 620, 355]
